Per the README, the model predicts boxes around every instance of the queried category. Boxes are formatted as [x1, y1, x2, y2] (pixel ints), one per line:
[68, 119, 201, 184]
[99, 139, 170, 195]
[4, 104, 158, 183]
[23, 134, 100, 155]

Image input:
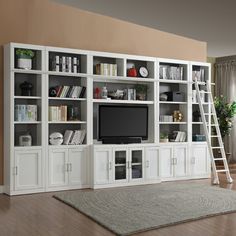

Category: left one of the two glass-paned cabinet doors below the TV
[114, 150, 128, 181]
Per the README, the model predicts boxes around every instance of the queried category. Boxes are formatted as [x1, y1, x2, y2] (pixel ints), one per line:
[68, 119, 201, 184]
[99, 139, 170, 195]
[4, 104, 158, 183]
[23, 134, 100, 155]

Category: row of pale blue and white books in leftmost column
[14, 105, 37, 122]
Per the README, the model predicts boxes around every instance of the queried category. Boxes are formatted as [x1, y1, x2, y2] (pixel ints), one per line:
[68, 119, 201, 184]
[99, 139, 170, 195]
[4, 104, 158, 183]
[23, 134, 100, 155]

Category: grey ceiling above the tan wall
[54, 0, 236, 57]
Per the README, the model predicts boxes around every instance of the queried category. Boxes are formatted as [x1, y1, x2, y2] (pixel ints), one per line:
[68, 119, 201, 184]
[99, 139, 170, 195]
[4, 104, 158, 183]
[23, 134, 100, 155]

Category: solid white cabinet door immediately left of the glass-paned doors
[93, 147, 112, 184]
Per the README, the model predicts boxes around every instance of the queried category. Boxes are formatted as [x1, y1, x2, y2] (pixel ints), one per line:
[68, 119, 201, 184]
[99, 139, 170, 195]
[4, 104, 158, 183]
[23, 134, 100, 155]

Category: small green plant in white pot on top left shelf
[16, 48, 34, 70]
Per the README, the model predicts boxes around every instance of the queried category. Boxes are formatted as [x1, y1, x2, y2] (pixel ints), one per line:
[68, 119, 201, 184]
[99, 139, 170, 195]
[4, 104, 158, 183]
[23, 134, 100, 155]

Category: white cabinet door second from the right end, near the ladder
[174, 146, 188, 177]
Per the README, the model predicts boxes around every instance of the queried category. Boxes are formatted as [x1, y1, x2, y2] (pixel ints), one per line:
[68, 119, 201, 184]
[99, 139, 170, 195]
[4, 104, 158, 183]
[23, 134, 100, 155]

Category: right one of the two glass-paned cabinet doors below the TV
[130, 149, 143, 179]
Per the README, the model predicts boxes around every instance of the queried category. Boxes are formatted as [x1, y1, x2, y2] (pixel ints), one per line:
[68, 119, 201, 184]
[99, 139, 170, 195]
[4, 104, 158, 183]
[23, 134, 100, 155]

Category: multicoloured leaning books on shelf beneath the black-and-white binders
[51, 85, 86, 98]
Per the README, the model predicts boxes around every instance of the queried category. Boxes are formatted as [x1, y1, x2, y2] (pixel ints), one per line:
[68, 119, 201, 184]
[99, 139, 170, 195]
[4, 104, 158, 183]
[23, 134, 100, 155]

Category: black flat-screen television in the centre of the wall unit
[98, 105, 148, 140]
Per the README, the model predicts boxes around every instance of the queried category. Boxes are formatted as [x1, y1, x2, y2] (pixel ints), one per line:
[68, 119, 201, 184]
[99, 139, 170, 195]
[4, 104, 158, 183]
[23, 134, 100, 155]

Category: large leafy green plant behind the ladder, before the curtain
[214, 95, 236, 138]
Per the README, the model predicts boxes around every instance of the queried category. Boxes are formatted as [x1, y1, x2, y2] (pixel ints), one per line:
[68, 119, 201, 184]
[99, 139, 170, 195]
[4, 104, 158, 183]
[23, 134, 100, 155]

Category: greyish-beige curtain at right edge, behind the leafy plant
[215, 60, 236, 162]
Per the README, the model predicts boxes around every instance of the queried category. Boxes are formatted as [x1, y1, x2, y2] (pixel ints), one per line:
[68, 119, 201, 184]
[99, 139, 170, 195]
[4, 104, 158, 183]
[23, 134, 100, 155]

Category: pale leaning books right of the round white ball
[63, 130, 86, 145]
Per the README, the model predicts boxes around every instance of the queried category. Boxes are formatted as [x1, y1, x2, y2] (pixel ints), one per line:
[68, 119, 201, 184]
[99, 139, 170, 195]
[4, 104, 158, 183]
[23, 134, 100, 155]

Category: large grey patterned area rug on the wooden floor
[54, 183, 236, 235]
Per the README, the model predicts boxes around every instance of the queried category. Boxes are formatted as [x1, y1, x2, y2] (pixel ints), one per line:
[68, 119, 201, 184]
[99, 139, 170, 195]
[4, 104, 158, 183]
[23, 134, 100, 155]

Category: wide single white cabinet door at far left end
[13, 150, 43, 190]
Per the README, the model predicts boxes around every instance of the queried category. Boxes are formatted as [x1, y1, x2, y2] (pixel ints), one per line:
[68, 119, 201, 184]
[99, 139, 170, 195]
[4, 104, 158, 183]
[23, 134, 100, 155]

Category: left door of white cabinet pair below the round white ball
[48, 148, 68, 187]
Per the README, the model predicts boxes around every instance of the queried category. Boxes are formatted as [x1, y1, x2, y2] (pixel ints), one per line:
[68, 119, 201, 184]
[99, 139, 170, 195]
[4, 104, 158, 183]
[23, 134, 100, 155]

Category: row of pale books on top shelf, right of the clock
[159, 65, 184, 80]
